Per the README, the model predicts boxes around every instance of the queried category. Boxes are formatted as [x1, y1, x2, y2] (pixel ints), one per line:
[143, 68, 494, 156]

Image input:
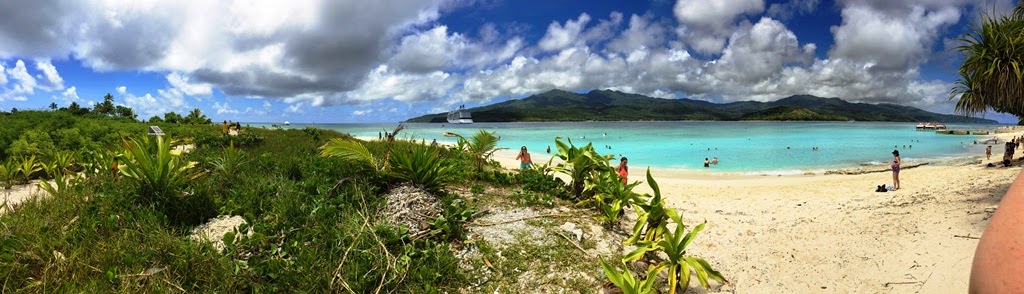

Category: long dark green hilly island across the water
[408, 89, 997, 124]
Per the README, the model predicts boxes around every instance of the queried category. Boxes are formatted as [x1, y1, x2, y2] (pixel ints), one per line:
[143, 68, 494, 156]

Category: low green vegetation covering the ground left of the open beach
[0, 110, 725, 293]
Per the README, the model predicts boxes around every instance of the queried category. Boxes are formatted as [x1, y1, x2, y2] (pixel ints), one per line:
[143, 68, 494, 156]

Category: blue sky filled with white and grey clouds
[0, 0, 1017, 123]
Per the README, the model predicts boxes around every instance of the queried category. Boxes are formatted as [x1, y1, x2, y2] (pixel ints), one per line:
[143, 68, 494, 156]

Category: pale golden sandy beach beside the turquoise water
[495, 130, 1021, 293]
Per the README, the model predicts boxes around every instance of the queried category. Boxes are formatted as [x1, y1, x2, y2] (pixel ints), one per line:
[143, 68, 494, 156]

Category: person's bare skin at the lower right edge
[970, 169, 1024, 293]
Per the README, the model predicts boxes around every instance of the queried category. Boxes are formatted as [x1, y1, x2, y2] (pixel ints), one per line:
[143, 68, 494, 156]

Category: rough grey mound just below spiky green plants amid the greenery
[380, 185, 442, 236]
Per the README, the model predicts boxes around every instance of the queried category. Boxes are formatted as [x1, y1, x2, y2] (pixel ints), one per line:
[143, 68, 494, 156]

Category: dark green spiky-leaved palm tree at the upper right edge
[949, 3, 1024, 123]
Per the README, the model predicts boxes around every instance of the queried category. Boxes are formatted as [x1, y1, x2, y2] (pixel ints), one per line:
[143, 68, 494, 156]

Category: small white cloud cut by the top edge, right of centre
[672, 0, 764, 53]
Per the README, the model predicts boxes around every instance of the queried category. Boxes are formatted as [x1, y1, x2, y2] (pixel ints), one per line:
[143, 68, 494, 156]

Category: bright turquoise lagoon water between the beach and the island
[270, 122, 1001, 174]
